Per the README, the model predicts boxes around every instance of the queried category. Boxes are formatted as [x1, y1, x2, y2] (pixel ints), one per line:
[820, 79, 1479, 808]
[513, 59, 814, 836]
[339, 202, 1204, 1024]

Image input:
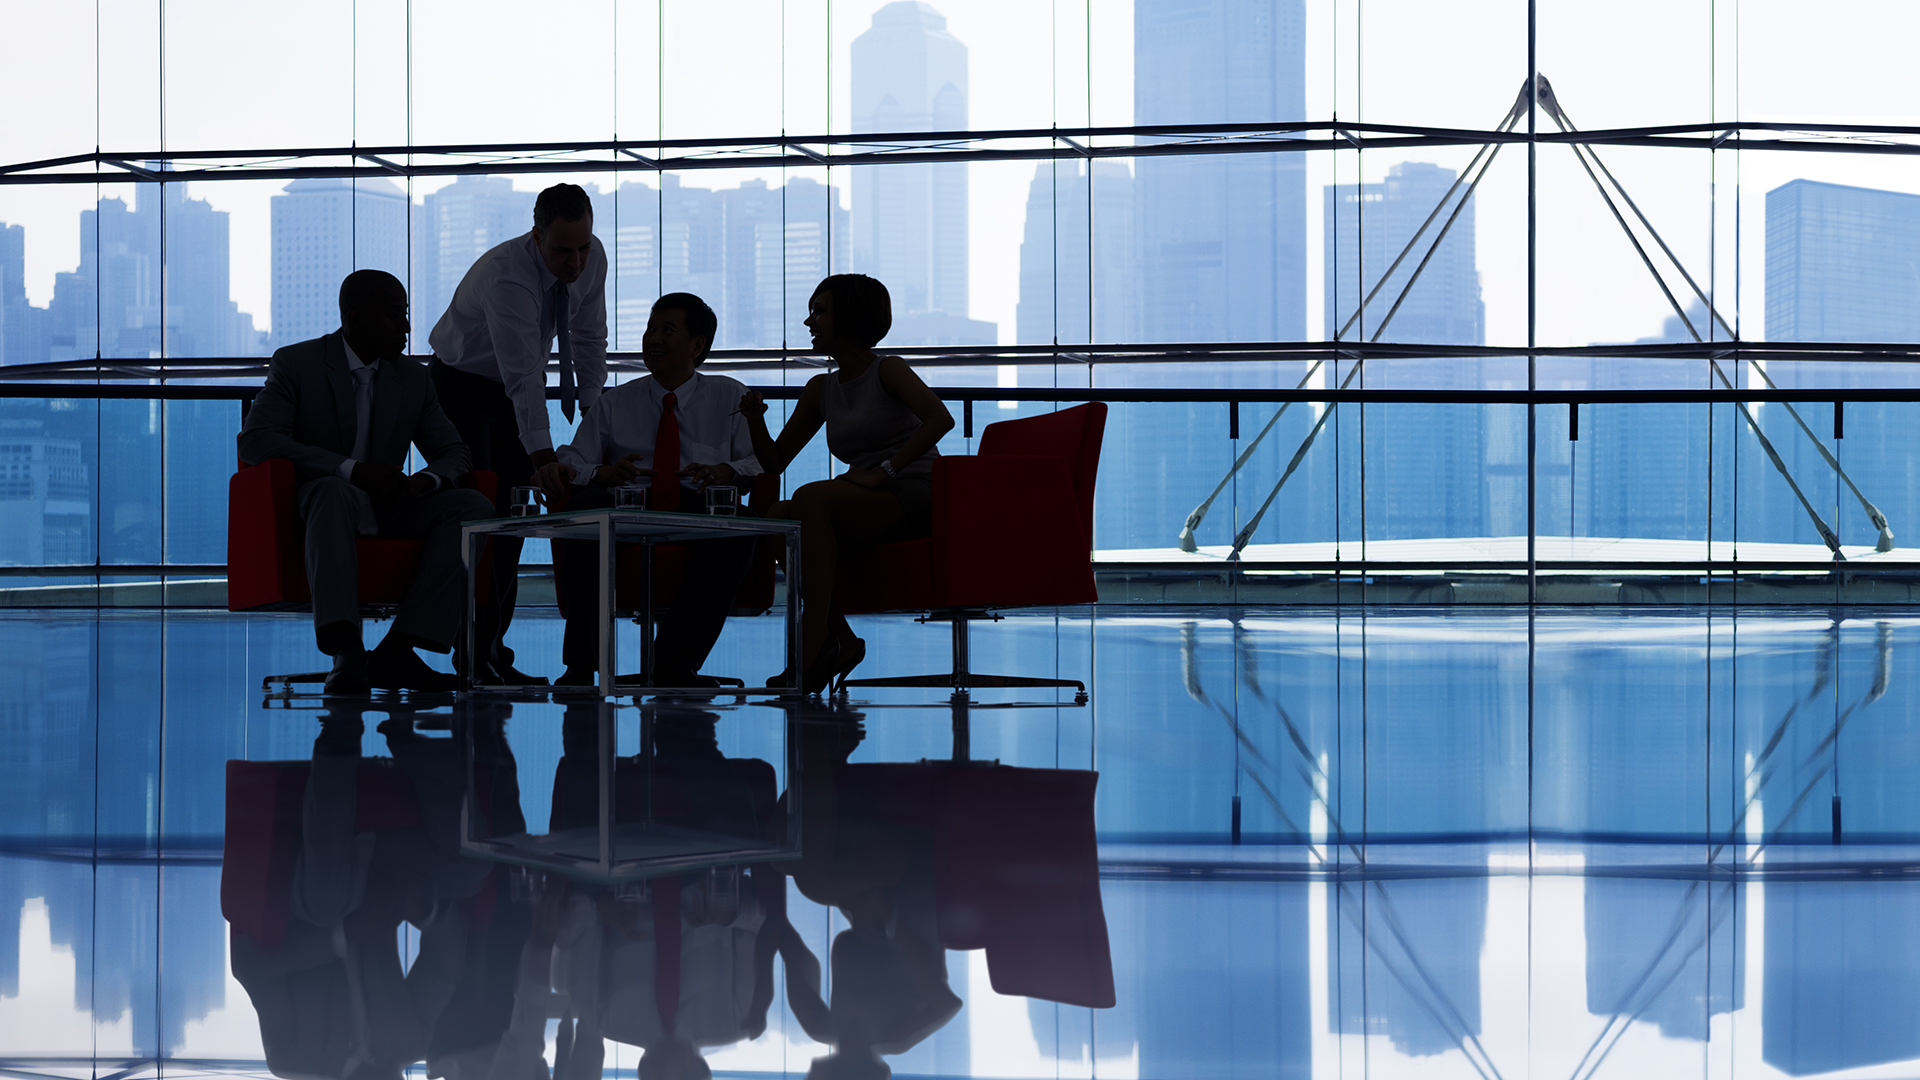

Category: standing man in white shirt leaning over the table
[428, 184, 607, 682]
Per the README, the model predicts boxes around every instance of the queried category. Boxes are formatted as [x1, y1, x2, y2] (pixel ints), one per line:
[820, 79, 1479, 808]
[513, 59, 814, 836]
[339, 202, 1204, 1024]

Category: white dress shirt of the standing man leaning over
[426, 233, 607, 454]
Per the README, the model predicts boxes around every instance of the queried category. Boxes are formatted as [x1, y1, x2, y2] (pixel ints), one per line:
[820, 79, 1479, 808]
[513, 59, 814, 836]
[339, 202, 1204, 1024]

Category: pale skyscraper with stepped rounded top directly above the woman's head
[852, 0, 996, 346]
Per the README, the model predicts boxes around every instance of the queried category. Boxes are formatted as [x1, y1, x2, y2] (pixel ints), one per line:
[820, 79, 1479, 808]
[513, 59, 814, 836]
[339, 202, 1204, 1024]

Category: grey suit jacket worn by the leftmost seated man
[240, 331, 472, 478]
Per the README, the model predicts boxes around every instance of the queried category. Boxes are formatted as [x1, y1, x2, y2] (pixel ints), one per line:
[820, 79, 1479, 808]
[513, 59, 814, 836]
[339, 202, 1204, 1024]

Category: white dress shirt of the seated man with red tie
[557, 371, 760, 484]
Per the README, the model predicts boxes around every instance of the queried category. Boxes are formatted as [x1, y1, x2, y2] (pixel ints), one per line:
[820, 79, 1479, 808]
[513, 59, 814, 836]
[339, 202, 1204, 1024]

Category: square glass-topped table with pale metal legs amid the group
[461, 507, 801, 696]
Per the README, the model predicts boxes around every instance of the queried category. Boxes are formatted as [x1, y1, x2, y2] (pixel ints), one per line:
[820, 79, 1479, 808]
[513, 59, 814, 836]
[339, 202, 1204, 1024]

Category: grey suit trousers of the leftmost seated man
[296, 477, 493, 651]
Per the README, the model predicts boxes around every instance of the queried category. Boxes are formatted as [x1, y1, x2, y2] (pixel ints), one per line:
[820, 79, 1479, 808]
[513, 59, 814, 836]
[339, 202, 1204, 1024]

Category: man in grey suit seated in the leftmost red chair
[240, 269, 493, 694]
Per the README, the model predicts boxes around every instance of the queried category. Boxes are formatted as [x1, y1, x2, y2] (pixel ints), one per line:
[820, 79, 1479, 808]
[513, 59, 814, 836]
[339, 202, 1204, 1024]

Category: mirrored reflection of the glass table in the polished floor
[455, 698, 801, 884]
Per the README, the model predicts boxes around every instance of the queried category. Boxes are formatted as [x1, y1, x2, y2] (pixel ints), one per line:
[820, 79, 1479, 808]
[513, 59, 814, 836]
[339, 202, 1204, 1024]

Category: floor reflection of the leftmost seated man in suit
[223, 709, 490, 1080]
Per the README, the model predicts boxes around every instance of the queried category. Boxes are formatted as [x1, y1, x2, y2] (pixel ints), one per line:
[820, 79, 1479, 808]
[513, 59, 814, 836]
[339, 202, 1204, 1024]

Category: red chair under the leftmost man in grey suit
[227, 457, 495, 690]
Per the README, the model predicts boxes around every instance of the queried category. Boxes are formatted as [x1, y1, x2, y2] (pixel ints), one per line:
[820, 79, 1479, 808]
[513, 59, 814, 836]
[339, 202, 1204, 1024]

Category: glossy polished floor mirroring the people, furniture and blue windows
[0, 607, 1920, 1080]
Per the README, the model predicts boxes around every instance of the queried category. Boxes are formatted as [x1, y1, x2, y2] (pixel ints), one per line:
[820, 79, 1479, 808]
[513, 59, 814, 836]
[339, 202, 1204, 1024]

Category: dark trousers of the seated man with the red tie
[553, 486, 755, 671]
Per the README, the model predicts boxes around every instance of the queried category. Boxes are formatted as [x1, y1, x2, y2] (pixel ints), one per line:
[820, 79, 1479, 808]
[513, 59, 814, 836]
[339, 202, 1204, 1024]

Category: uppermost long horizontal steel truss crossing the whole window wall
[0, 121, 1920, 184]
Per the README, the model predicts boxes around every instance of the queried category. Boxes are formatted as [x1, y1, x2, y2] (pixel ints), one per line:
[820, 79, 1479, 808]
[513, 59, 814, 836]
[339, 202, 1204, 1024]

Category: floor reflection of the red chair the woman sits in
[835, 763, 1114, 1009]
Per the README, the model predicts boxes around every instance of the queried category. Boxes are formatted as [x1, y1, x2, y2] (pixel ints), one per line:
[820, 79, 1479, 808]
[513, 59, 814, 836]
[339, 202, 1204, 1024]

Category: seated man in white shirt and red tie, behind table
[536, 292, 760, 686]
